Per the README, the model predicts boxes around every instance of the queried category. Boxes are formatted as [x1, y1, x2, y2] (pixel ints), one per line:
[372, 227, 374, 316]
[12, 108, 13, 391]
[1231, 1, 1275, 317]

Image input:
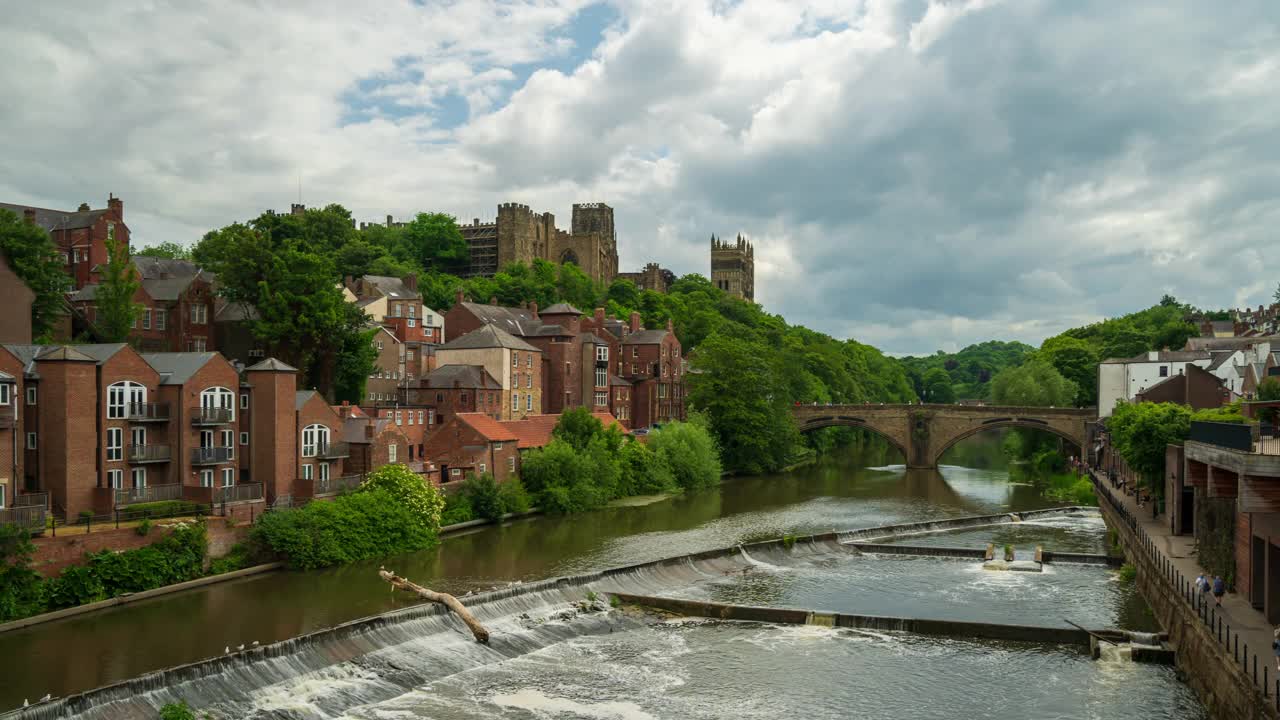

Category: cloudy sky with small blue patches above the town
[0, 0, 1280, 354]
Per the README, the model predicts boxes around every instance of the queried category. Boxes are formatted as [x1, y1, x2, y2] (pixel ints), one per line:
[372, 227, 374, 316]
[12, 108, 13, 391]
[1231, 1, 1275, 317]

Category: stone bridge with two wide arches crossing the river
[791, 404, 1098, 468]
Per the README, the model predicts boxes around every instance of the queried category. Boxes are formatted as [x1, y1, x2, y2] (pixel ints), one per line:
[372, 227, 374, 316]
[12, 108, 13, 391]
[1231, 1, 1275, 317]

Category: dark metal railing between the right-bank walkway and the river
[1089, 468, 1280, 711]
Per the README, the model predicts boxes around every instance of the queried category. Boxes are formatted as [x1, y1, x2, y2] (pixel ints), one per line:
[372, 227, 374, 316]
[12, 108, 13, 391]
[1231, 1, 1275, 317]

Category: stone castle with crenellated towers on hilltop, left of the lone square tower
[460, 202, 618, 284]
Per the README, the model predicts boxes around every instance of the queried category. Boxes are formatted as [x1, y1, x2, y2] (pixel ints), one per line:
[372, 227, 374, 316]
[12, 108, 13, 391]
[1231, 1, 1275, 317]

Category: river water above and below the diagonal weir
[0, 435, 1204, 719]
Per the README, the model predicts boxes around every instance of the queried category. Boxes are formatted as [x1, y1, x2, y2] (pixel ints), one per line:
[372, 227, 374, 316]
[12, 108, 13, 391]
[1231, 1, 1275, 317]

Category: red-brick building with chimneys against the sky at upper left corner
[0, 195, 129, 290]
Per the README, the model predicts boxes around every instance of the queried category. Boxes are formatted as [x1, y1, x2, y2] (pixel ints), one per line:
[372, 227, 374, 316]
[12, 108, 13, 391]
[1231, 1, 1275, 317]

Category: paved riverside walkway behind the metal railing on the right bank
[1093, 475, 1280, 710]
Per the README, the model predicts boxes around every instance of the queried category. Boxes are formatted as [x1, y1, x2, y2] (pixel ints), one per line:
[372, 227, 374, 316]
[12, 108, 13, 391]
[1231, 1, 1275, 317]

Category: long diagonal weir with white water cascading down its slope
[0, 509, 1131, 720]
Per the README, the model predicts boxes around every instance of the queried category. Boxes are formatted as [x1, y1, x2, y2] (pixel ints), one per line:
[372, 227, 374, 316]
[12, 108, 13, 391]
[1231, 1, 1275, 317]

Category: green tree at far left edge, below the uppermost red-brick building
[0, 210, 72, 342]
